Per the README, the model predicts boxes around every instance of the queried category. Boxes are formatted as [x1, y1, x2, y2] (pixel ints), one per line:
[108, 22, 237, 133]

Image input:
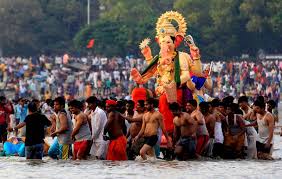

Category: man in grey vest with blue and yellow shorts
[48, 97, 72, 160]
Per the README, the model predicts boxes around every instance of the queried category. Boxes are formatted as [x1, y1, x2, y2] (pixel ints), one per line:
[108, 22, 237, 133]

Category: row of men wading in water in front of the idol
[0, 93, 277, 160]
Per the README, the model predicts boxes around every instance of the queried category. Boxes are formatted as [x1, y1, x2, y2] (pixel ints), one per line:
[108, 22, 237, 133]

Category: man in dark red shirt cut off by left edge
[0, 96, 13, 144]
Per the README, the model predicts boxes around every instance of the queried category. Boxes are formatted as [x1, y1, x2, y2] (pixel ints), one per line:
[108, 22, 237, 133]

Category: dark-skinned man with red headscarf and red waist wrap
[104, 100, 127, 160]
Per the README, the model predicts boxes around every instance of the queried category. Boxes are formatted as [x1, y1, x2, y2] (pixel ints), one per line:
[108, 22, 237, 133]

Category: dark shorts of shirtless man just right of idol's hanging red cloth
[176, 137, 196, 158]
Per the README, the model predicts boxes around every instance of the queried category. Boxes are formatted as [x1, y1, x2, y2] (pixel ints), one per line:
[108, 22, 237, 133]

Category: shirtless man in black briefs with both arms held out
[133, 98, 172, 160]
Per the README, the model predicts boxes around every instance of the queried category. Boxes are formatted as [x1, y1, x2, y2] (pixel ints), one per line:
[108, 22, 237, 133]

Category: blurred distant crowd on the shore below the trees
[0, 55, 282, 103]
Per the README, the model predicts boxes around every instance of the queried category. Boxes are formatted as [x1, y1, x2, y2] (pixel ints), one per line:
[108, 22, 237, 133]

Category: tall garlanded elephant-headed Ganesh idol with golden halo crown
[131, 11, 213, 133]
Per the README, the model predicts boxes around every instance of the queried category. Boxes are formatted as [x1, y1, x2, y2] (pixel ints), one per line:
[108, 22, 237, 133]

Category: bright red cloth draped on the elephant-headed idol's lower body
[159, 89, 182, 132]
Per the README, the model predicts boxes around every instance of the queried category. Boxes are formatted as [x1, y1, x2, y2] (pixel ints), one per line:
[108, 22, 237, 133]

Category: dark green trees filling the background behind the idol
[0, 0, 282, 58]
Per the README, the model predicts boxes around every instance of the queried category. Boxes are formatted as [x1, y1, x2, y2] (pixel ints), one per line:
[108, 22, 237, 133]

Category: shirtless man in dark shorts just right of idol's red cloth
[169, 103, 198, 160]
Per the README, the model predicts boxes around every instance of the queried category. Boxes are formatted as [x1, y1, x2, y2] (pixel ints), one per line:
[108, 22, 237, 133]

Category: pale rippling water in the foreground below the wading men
[0, 136, 282, 179]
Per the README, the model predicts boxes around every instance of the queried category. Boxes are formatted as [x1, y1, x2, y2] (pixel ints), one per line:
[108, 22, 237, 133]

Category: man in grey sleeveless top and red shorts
[68, 100, 91, 160]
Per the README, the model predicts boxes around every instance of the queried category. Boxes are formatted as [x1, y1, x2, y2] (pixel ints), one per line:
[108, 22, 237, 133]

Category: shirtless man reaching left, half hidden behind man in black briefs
[124, 100, 145, 160]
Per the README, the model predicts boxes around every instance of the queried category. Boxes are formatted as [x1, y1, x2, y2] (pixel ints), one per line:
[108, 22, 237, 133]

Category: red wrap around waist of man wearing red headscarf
[107, 135, 127, 160]
